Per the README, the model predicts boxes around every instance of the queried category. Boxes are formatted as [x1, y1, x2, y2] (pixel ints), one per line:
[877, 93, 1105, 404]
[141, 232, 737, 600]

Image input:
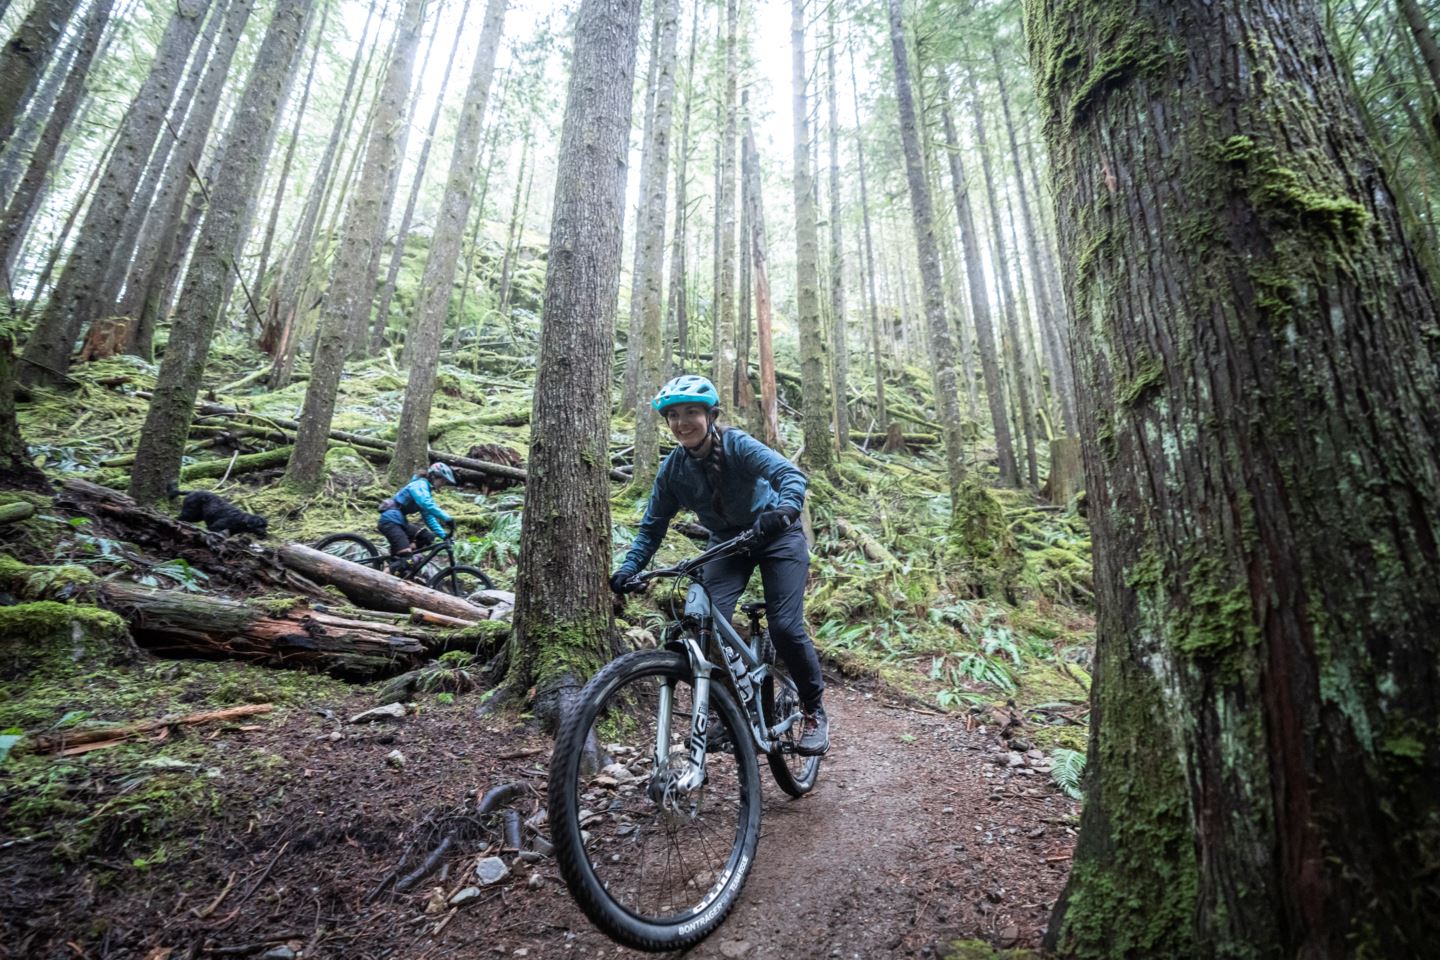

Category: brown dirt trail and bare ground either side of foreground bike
[0, 681, 1079, 960]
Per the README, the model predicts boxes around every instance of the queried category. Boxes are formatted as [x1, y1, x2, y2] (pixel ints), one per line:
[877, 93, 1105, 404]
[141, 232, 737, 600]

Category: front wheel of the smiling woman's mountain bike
[549, 651, 760, 951]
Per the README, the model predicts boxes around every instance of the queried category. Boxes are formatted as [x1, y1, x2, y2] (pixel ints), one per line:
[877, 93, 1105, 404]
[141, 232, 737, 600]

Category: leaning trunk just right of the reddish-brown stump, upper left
[118, 0, 255, 360]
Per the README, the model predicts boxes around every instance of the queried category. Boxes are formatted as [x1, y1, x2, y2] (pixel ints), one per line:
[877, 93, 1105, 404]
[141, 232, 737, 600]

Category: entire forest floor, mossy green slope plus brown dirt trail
[0, 347, 1094, 960]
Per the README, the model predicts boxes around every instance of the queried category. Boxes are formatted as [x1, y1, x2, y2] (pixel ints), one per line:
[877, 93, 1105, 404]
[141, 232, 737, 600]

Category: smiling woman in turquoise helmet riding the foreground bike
[611, 374, 829, 756]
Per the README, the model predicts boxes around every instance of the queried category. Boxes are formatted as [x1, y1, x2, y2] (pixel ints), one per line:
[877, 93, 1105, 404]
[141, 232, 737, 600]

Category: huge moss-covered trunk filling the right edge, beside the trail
[1027, 0, 1440, 957]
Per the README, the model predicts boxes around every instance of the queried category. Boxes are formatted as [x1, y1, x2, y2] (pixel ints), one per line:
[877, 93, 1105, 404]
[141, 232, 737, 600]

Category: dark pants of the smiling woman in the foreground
[703, 524, 825, 710]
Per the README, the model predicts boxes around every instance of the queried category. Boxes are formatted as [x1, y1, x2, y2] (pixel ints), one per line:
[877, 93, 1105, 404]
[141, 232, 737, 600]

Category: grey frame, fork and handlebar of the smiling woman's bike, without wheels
[636, 533, 801, 790]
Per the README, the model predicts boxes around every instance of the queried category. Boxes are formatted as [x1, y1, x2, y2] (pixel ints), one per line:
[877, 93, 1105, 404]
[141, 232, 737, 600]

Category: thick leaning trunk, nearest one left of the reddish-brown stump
[20, 0, 210, 384]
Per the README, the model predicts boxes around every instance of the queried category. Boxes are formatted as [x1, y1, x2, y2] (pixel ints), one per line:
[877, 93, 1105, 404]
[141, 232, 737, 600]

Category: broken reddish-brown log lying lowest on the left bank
[95, 580, 439, 679]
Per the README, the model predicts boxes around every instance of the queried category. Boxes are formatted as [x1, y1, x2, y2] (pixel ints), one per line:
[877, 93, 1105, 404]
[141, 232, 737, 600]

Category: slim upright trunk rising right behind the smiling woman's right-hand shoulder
[791, 0, 835, 472]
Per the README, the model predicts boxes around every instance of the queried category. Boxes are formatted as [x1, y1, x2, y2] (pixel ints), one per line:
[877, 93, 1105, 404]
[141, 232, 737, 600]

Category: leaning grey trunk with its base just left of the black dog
[130, 0, 310, 504]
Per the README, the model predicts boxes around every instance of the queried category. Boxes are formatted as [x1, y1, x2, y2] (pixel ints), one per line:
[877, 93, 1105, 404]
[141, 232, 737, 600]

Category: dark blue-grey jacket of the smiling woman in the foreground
[624, 427, 809, 573]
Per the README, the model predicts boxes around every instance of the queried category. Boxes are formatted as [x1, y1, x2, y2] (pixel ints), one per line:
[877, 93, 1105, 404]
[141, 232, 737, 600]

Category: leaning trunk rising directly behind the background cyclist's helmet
[387, 0, 505, 485]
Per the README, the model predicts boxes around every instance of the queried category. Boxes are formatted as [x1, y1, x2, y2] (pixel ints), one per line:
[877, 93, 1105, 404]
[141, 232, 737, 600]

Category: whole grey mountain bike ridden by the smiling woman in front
[549, 533, 819, 951]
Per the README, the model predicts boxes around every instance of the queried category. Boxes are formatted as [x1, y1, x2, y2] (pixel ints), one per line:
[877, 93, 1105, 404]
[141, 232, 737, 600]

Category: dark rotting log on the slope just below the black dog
[55, 479, 327, 599]
